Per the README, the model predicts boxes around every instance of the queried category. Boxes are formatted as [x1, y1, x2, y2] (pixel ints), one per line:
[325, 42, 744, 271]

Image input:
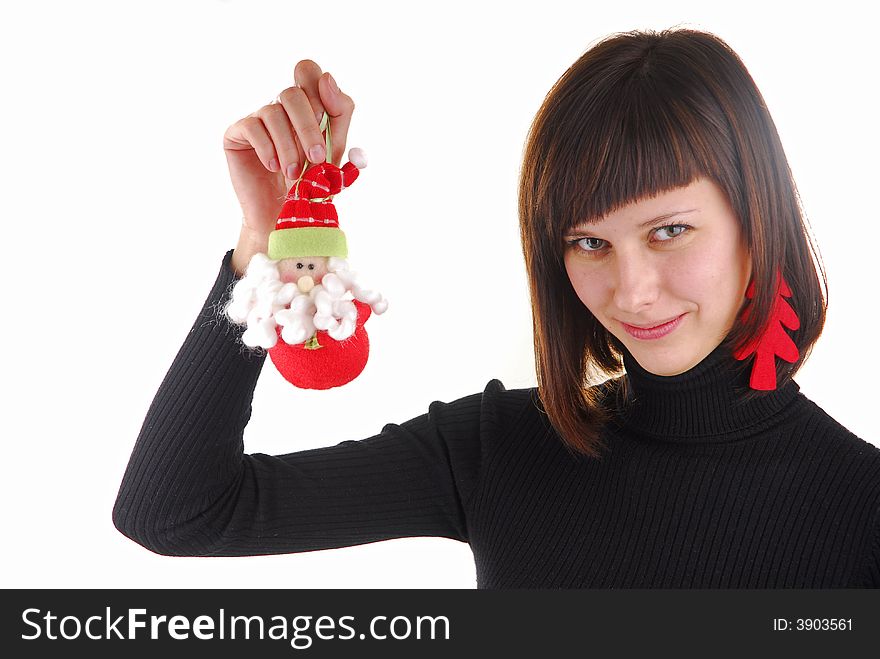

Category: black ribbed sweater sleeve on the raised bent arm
[113, 250, 488, 556]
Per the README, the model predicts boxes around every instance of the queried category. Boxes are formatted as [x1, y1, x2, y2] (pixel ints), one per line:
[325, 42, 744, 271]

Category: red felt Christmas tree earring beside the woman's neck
[733, 270, 801, 391]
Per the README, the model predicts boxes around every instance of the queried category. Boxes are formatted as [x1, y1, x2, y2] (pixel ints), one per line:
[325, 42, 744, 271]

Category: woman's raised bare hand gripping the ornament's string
[223, 59, 354, 275]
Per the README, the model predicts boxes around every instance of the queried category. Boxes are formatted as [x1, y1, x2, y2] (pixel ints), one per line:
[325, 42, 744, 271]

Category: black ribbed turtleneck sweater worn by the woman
[113, 251, 880, 588]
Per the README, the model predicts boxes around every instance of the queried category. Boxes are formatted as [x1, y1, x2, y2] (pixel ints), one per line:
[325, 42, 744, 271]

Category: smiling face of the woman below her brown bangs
[565, 179, 752, 375]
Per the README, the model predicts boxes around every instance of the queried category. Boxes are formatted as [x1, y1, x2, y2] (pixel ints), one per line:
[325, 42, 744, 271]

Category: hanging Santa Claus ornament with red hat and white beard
[225, 112, 388, 389]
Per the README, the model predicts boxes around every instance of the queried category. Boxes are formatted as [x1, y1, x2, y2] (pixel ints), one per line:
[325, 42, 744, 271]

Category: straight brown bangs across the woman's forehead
[544, 67, 735, 239]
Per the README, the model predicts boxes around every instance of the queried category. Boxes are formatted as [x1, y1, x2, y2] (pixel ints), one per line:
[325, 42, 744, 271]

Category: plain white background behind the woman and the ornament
[0, 0, 880, 588]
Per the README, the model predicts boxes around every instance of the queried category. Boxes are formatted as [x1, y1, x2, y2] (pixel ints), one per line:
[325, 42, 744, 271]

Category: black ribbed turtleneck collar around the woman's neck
[618, 343, 800, 443]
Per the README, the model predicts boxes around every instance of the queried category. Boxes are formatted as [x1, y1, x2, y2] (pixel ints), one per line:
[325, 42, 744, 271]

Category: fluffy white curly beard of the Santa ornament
[223, 254, 388, 350]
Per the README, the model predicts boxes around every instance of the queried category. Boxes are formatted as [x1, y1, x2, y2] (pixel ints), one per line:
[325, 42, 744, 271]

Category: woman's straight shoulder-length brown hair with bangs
[519, 29, 827, 458]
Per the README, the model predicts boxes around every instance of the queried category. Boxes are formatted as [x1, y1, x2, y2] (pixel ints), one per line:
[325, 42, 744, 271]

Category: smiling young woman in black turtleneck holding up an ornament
[113, 30, 880, 588]
